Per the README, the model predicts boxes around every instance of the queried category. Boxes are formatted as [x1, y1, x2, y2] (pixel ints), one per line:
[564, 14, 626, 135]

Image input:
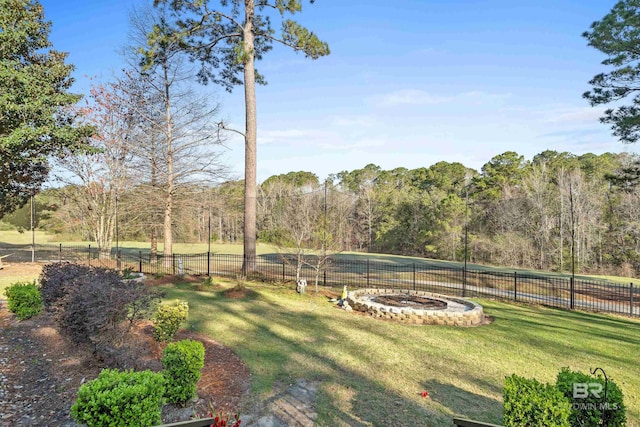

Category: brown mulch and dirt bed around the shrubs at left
[0, 306, 251, 427]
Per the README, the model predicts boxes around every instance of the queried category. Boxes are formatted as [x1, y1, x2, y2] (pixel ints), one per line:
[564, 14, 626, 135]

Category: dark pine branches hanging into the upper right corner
[583, 0, 640, 143]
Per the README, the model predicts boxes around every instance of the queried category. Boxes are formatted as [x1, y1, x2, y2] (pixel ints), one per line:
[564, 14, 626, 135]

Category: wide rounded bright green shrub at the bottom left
[71, 369, 165, 427]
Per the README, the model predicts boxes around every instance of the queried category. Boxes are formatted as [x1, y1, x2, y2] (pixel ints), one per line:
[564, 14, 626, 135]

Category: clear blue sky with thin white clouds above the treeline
[42, 0, 635, 181]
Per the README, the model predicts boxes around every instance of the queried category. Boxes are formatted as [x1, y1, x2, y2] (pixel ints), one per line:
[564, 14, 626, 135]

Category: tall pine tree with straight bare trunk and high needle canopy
[146, 0, 329, 273]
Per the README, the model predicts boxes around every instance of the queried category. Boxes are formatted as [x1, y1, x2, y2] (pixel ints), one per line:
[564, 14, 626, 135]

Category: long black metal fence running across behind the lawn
[0, 245, 640, 316]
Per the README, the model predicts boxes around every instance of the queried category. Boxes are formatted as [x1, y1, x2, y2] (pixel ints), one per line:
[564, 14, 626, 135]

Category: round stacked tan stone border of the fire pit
[347, 289, 484, 326]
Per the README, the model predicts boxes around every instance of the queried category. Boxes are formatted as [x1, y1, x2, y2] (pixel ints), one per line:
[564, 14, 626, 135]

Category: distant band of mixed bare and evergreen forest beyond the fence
[3, 151, 640, 277]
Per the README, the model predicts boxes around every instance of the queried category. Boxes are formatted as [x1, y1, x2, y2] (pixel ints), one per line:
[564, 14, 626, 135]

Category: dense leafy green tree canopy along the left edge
[0, 0, 93, 217]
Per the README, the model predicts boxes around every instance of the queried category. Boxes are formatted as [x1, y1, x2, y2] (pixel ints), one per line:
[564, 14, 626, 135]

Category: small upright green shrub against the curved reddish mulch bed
[162, 340, 204, 403]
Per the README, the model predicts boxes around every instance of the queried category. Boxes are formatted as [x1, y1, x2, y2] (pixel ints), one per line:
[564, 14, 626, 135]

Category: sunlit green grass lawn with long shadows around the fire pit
[159, 282, 640, 426]
